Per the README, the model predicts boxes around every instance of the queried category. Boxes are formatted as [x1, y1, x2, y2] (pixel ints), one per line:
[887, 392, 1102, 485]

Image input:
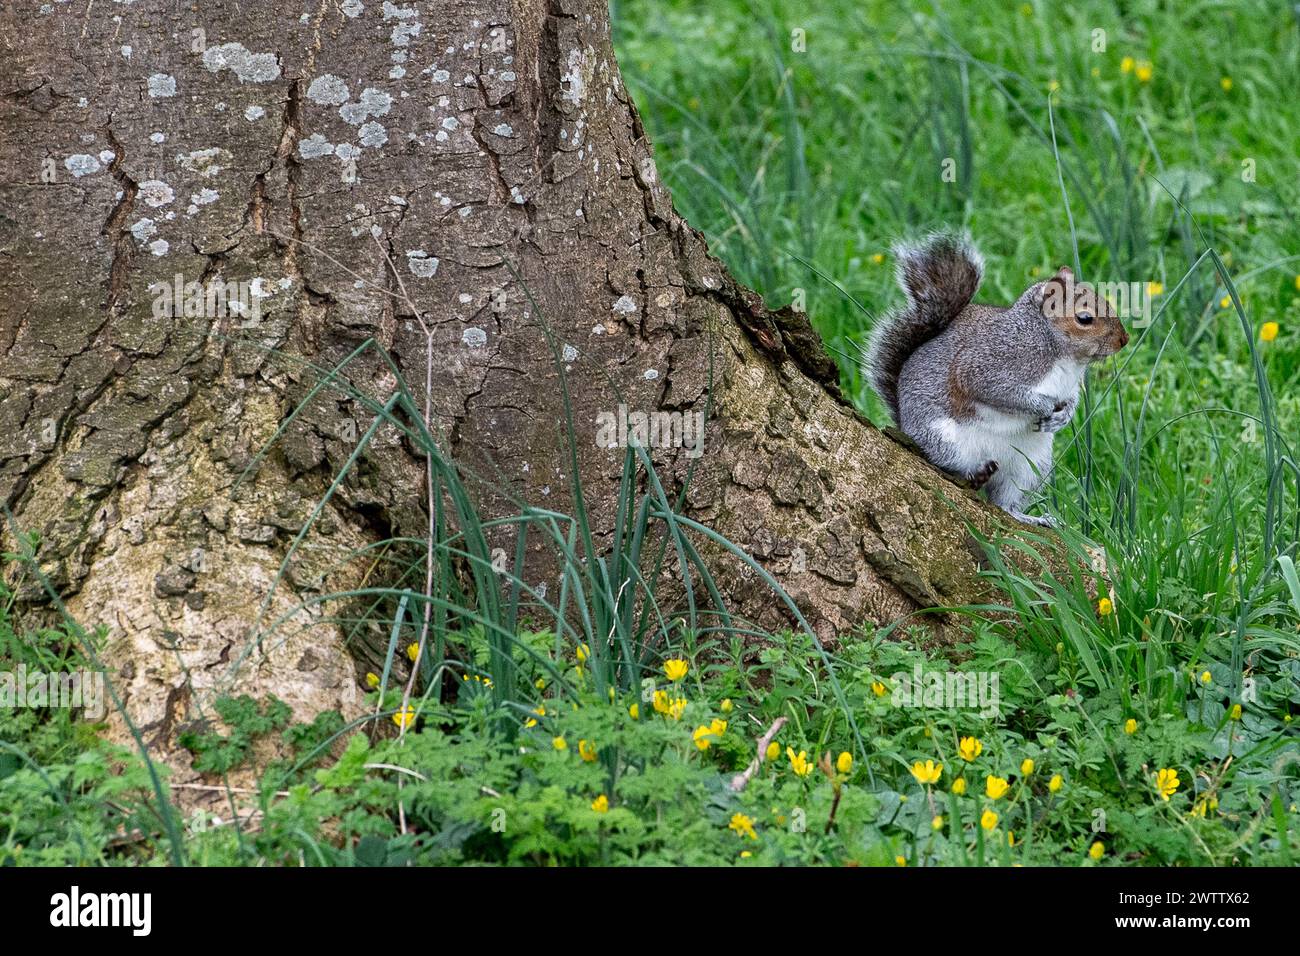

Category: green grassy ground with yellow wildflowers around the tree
[0, 0, 1300, 866]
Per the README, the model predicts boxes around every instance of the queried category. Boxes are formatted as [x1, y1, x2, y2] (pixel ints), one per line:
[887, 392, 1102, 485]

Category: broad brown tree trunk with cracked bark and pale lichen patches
[0, 0, 995, 770]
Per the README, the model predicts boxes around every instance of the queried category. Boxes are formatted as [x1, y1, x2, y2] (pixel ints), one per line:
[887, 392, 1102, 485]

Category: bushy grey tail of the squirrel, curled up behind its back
[866, 234, 984, 423]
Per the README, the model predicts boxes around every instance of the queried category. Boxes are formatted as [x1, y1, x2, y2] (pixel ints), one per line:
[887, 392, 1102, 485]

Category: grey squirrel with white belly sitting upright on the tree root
[866, 234, 1128, 527]
